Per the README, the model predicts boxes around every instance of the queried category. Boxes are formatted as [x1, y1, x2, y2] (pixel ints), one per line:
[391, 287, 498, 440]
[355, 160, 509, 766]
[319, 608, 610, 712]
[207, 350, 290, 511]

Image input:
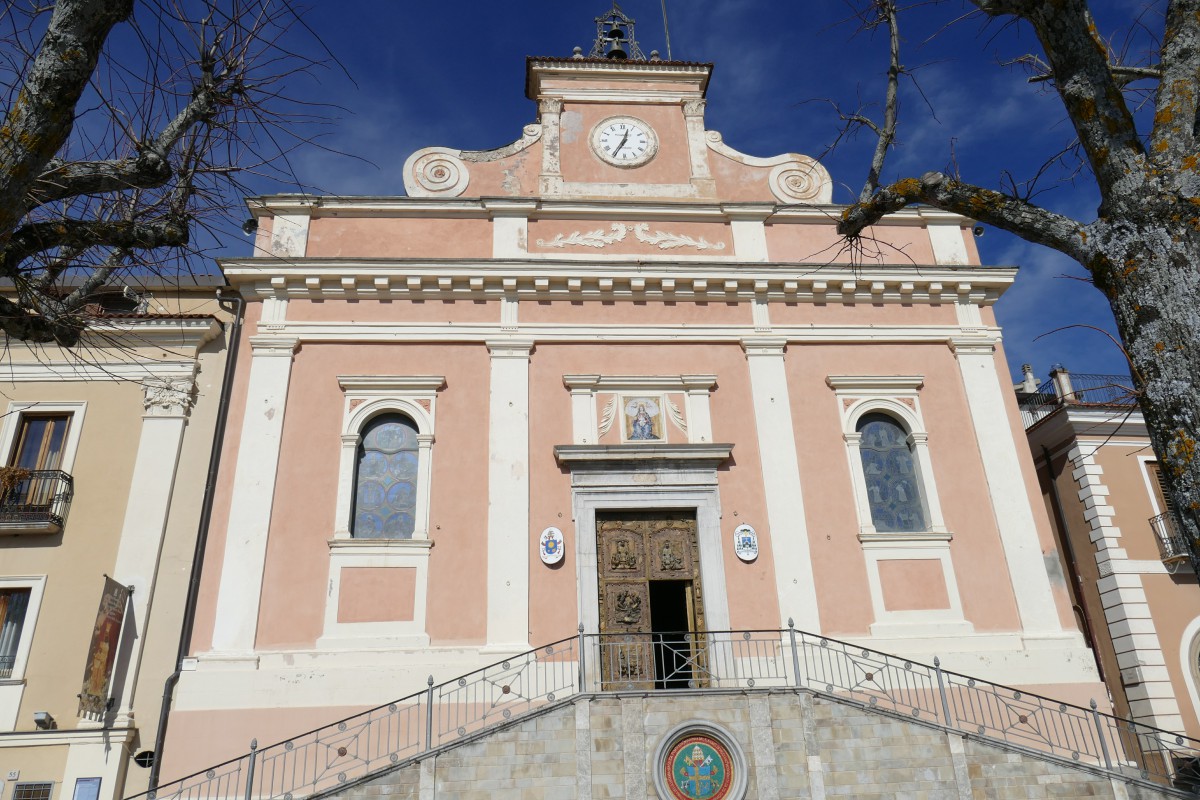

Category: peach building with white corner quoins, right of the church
[1018, 368, 1200, 736]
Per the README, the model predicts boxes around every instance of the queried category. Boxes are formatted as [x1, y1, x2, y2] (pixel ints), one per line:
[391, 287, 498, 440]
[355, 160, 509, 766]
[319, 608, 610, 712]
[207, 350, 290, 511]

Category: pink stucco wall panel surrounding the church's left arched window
[257, 344, 488, 649]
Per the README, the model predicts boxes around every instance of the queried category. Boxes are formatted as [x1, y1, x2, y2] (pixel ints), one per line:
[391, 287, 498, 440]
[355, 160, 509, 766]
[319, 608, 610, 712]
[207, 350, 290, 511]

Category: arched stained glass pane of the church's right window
[858, 414, 926, 531]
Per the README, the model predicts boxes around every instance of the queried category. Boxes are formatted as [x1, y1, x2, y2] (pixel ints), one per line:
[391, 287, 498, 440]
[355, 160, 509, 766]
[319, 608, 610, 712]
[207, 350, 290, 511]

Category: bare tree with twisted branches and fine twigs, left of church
[0, 0, 336, 347]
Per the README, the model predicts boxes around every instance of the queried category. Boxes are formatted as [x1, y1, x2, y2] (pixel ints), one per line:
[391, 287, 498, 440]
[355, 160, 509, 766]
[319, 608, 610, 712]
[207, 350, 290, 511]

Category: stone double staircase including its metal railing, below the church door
[131, 627, 1200, 800]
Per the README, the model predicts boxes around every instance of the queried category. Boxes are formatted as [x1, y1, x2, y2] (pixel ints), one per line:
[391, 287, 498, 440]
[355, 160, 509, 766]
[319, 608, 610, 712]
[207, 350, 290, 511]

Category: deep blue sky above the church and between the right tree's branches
[253, 0, 1163, 378]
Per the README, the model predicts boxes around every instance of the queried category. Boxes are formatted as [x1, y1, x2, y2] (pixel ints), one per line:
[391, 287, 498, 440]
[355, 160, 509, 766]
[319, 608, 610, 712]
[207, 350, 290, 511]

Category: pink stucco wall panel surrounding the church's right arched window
[787, 343, 1020, 636]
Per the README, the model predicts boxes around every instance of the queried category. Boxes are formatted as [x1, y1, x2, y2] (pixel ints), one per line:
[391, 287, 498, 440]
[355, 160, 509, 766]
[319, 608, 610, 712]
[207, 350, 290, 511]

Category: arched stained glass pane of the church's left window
[353, 414, 418, 539]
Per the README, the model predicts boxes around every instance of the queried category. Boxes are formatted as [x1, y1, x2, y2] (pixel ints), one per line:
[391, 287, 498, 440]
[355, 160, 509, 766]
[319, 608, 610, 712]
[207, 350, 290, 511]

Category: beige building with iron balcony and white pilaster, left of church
[0, 278, 234, 800]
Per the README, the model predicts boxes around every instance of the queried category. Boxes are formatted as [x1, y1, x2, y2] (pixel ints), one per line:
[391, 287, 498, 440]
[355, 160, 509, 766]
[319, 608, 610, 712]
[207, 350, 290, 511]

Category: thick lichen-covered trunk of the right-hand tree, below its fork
[1085, 209, 1200, 552]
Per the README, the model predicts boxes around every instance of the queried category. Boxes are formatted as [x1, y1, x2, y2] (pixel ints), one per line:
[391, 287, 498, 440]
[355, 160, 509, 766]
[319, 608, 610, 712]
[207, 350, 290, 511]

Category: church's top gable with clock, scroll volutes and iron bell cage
[404, 2, 832, 204]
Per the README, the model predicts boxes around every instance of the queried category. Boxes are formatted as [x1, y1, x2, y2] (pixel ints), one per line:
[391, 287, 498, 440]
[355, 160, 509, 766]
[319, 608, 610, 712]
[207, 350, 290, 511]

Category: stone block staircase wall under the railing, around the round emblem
[325, 690, 1194, 800]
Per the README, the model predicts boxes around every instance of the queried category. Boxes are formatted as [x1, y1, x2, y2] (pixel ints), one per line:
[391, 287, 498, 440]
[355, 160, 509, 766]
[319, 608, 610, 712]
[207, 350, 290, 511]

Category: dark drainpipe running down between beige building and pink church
[149, 289, 246, 789]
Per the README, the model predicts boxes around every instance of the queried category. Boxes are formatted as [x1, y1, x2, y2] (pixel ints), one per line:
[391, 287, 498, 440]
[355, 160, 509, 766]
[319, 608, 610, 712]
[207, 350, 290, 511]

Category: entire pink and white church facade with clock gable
[160, 17, 1105, 781]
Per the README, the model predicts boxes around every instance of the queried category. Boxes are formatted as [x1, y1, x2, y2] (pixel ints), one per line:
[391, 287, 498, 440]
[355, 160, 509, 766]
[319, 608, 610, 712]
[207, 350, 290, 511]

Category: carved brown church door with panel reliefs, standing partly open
[596, 512, 704, 688]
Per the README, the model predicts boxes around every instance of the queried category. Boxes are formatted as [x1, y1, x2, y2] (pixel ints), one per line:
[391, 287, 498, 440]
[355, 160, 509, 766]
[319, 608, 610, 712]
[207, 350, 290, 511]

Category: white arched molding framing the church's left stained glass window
[334, 375, 445, 540]
